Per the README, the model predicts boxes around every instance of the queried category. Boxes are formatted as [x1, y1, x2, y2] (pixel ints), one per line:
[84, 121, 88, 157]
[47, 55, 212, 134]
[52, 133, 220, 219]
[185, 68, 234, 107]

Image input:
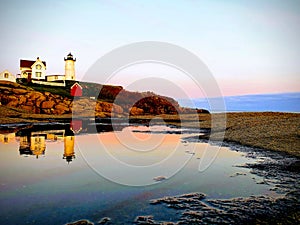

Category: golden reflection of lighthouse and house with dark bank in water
[0, 119, 124, 163]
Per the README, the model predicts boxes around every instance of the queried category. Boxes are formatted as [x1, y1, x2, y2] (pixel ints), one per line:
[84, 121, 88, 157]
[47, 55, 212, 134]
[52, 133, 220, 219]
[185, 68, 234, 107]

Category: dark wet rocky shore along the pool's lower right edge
[63, 140, 300, 225]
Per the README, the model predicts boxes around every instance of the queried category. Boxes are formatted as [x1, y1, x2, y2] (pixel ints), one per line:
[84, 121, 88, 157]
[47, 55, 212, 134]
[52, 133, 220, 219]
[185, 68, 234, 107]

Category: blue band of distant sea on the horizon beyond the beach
[177, 92, 300, 113]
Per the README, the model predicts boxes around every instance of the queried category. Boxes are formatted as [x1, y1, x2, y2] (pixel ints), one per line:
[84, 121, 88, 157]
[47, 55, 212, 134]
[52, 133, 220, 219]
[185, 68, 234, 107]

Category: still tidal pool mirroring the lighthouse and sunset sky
[0, 123, 273, 224]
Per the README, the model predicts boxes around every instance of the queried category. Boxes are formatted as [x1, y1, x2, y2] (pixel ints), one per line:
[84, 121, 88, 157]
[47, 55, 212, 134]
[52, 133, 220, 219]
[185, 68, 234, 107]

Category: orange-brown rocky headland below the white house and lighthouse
[0, 81, 204, 118]
